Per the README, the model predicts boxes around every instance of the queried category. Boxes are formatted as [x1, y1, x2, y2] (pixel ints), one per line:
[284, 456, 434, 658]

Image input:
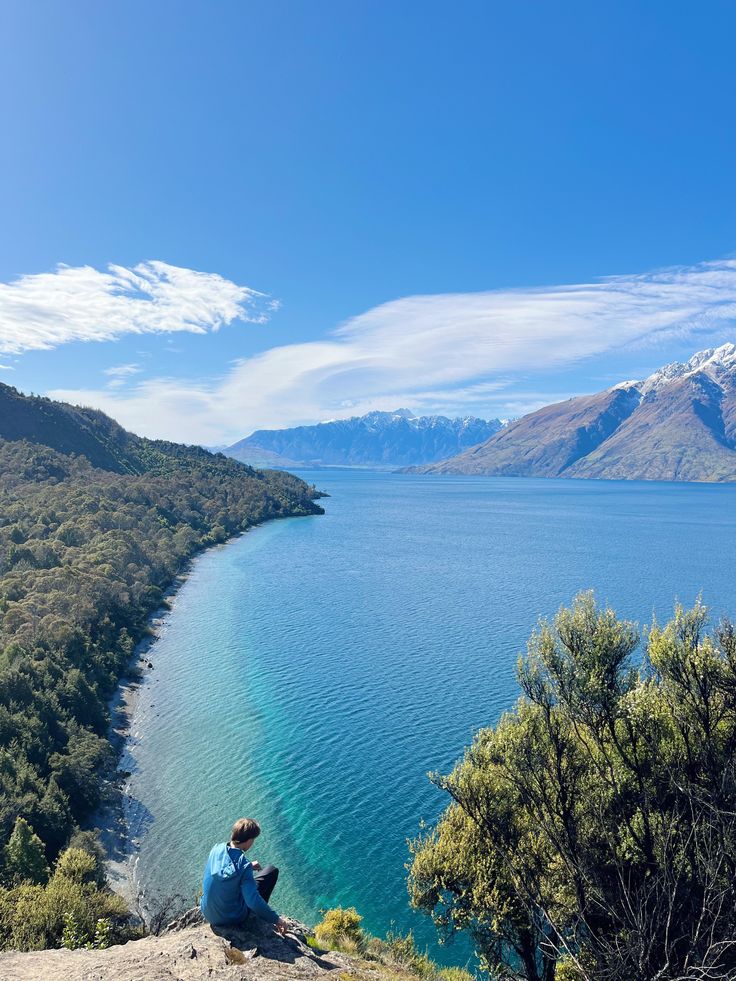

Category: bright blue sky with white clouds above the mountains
[0, 0, 736, 443]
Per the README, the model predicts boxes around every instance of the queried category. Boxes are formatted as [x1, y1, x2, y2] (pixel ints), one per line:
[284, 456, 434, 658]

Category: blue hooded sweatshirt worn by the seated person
[199, 842, 279, 926]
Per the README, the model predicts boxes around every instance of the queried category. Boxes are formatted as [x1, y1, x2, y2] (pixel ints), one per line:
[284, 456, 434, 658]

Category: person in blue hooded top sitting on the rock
[199, 818, 287, 936]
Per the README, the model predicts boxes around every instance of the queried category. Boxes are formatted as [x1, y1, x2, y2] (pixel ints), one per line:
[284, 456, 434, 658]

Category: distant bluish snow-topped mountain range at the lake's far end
[224, 409, 502, 468]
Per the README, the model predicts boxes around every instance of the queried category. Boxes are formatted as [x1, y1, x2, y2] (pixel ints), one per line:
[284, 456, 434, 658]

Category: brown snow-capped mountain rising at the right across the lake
[412, 343, 736, 481]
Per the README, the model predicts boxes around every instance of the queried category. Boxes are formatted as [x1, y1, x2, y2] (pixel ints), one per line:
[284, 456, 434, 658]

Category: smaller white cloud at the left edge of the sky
[0, 260, 272, 354]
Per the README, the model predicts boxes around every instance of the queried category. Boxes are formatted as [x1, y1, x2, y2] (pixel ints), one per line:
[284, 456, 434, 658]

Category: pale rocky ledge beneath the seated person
[0, 909, 360, 981]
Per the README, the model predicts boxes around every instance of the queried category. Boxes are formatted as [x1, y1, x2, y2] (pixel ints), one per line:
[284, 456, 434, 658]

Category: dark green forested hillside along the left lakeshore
[0, 387, 322, 939]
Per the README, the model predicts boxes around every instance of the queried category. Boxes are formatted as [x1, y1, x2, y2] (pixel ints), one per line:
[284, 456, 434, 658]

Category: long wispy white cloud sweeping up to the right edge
[47, 259, 736, 443]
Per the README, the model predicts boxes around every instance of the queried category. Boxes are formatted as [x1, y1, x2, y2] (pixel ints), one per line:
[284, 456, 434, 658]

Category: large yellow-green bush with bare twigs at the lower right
[409, 593, 736, 981]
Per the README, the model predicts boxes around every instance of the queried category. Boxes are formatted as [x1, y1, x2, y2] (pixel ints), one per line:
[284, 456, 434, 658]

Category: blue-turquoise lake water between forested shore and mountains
[125, 472, 736, 962]
